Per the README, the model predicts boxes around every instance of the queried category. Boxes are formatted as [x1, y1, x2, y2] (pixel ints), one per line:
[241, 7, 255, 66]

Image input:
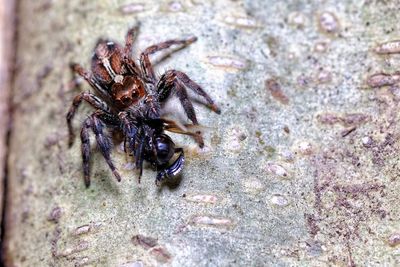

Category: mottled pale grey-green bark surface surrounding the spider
[7, 0, 400, 266]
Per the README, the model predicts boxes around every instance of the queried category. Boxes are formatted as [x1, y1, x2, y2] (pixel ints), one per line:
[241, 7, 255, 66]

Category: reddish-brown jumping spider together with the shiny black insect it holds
[66, 26, 220, 187]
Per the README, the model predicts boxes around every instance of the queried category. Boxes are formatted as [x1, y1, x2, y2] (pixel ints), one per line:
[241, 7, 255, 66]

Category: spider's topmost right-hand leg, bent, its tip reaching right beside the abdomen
[140, 37, 197, 84]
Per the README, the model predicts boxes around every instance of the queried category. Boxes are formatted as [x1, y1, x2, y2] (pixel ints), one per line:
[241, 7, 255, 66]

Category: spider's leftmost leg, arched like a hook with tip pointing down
[66, 92, 111, 147]
